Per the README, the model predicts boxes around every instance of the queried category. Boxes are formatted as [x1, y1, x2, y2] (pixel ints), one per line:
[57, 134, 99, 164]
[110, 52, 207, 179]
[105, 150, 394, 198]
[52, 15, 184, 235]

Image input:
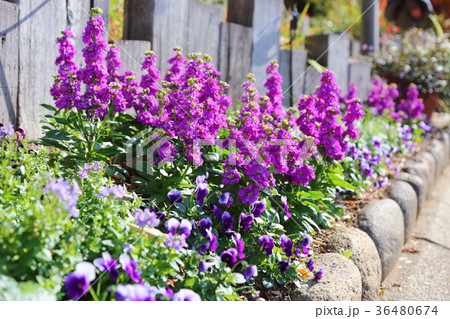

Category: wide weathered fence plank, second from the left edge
[18, 0, 67, 138]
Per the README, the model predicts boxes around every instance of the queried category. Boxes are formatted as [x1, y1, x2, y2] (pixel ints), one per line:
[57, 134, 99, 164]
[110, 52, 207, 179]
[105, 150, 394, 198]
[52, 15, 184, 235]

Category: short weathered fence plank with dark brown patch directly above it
[220, 22, 252, 105]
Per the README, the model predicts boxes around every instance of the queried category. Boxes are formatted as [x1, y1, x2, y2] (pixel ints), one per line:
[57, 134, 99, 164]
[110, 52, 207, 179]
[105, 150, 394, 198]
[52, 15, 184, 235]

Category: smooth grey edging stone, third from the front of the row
[358, 198, 405, 280]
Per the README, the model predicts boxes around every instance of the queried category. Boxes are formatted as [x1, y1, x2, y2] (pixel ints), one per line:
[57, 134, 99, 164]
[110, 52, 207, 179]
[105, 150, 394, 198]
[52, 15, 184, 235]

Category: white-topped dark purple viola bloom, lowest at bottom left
[64, 261, 95, 299]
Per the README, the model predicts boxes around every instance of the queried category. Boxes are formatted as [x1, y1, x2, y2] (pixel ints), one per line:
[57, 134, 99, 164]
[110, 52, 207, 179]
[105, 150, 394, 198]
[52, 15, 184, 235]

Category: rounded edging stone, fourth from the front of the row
[387, 181, 417, 243]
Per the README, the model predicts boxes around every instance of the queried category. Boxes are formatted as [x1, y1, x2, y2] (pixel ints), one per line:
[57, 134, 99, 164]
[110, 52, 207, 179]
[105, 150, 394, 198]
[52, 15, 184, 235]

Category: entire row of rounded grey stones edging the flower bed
[291, 128, 450, 301]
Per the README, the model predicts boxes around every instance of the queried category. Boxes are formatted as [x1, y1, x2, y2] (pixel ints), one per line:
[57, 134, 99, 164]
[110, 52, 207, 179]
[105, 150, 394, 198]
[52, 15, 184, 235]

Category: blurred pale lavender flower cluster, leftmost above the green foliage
[43, 177, 82, 217]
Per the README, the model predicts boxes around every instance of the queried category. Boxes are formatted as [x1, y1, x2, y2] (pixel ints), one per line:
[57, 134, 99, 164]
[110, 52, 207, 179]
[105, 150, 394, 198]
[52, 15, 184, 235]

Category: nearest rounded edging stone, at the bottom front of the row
[291, 253, 362, 301]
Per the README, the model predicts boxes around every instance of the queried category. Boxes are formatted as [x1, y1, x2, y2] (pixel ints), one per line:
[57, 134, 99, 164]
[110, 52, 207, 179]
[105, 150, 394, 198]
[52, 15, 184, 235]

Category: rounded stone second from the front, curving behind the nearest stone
[328, 227, 381, 300]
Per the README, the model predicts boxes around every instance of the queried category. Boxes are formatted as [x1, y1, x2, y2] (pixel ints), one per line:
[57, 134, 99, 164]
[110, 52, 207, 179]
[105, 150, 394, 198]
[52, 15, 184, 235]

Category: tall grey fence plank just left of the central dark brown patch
[186, 1, 224, 67]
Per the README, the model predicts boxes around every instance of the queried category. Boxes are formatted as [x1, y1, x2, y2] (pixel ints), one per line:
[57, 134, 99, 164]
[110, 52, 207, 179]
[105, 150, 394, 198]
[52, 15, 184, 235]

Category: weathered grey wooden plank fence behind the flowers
[0, 0, 370, 138]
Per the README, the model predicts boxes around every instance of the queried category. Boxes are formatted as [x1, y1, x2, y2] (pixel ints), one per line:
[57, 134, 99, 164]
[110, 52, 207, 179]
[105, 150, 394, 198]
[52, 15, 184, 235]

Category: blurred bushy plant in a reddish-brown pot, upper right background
[373, 29, 450, 118]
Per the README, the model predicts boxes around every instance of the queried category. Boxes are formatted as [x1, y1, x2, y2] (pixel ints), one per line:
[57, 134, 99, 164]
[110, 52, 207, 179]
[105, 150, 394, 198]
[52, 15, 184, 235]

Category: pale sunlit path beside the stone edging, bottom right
[380, 166, 450, 301]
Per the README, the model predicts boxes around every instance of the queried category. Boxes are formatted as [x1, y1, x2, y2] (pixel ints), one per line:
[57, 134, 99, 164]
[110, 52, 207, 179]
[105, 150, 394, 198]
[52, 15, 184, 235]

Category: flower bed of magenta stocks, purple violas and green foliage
[0, 9, 448, 300]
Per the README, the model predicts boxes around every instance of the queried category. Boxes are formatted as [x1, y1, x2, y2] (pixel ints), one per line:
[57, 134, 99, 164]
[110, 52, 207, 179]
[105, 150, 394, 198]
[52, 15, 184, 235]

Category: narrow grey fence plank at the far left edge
[0, 1, 19, 125]
